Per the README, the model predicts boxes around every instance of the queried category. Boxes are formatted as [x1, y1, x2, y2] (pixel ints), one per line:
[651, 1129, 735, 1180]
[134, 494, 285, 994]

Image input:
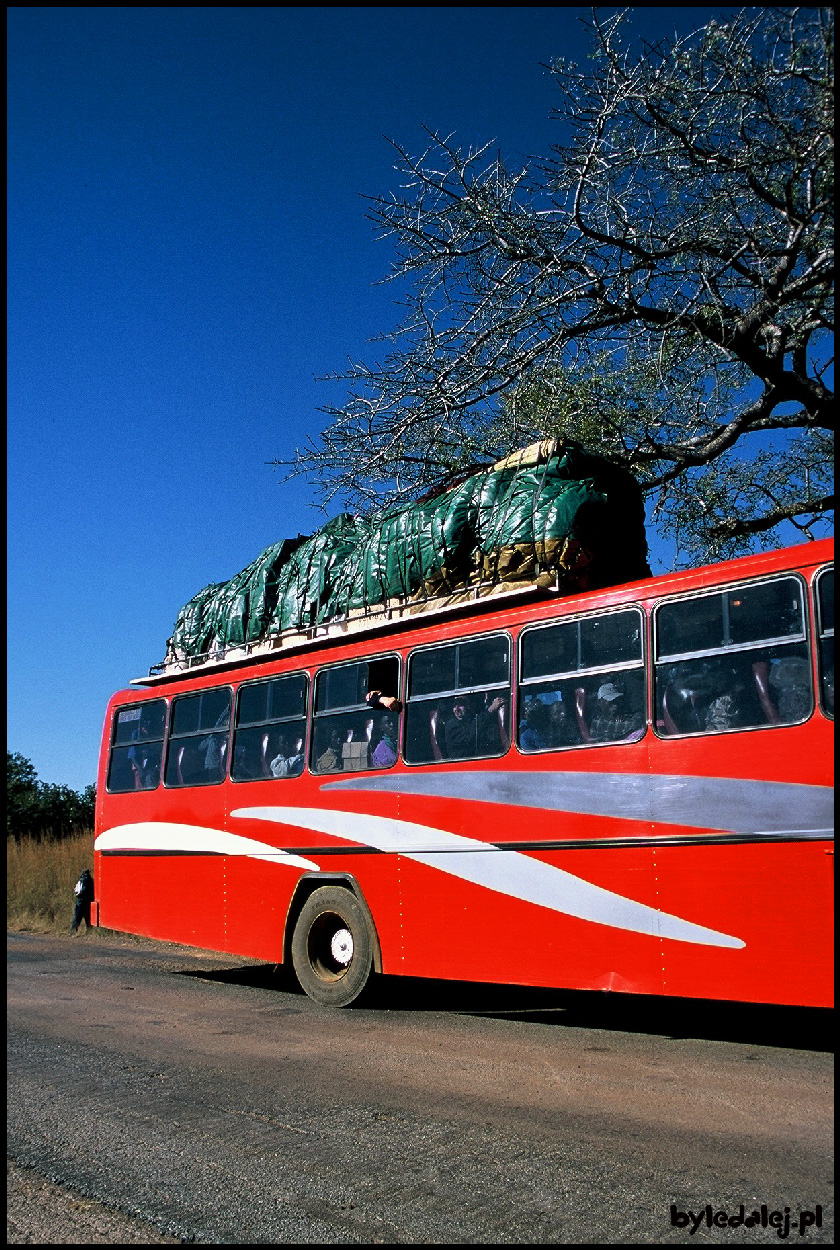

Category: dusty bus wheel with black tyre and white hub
[291, 885, 374, 1008]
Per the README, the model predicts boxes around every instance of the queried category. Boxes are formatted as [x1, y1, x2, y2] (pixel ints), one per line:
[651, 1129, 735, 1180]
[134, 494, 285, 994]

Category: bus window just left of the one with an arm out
[230, 673, 309, 781]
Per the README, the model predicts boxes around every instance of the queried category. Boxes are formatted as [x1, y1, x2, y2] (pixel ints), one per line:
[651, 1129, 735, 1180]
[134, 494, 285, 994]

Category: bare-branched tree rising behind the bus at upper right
[283, 8, 834, 558]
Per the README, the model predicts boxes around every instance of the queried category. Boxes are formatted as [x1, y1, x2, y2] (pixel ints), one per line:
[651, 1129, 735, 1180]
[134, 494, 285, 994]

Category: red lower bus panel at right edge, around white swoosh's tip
[656, 843, 834, 1006]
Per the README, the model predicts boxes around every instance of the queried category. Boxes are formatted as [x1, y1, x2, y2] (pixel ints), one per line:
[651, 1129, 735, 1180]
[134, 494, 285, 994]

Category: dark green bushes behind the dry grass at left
[6, 750, 96, 839]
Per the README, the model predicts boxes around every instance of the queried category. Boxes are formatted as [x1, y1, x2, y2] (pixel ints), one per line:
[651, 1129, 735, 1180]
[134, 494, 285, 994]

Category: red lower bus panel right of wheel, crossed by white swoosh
[392, 849, 663, 994]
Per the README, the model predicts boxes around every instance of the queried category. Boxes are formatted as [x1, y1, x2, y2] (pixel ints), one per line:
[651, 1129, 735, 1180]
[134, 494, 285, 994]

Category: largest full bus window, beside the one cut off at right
[655, 578, 813, 736]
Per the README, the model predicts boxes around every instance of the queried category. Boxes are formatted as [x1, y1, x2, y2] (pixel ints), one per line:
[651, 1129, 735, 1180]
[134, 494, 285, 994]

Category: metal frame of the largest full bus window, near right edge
[650, 569, 818, 743]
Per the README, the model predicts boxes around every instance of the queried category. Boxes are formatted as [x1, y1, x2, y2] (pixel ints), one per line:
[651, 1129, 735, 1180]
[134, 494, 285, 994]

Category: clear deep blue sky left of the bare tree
[8, 8, 733, 789]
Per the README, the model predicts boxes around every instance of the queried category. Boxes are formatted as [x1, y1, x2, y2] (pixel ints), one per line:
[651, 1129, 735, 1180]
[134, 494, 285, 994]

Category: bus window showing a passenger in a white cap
[516, 608, 645, 751]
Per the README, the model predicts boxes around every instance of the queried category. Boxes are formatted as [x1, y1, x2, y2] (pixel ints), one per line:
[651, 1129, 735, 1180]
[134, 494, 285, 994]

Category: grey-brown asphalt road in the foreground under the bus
[8, 934, 834, 1245]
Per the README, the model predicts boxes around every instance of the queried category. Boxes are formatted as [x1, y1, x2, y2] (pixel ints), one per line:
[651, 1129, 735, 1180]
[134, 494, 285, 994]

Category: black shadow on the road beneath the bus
[172, 964, 834, 1054]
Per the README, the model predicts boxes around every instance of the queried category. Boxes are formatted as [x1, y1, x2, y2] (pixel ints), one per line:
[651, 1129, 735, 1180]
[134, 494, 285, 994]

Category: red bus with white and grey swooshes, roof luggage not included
[95, 540, 834, 1006]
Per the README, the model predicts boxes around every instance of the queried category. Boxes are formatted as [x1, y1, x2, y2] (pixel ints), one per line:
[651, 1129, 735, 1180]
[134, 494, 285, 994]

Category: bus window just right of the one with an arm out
[405, 634, 510, 764]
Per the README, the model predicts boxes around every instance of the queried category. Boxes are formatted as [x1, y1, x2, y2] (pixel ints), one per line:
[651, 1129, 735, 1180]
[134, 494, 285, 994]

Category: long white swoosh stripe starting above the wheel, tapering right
[231, 808, 745, 949]
